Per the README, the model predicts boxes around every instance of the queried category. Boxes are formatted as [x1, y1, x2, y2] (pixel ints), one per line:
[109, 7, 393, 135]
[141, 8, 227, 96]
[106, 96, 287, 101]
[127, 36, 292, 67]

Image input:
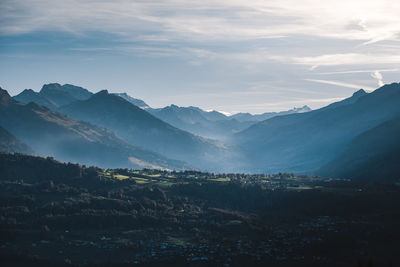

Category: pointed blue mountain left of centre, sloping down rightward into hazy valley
[59, 90, 233, 169]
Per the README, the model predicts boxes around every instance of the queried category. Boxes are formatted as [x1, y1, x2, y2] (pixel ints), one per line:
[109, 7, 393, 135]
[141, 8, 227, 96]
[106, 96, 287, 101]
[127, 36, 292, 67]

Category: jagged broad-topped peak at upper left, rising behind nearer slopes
[14, 83, 92, 110]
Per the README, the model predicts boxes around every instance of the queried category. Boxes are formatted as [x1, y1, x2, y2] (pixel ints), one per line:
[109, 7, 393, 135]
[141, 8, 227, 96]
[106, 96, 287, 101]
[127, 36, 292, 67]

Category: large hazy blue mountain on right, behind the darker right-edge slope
[235, 83, 400, 176]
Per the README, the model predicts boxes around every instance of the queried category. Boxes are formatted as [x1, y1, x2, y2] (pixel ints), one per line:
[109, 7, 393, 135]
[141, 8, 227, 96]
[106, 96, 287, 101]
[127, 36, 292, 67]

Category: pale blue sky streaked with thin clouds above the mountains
[0, 0, 400, 113]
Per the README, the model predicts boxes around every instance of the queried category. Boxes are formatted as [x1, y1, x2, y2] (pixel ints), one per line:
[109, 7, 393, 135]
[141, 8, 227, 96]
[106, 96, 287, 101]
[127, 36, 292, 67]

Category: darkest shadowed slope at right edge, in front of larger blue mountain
[317, 117, 400, 181]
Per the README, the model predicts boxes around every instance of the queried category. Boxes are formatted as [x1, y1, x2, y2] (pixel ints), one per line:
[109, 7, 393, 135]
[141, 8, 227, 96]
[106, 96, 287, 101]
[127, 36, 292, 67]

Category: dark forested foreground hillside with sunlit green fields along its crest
[0, 153, 400, 267]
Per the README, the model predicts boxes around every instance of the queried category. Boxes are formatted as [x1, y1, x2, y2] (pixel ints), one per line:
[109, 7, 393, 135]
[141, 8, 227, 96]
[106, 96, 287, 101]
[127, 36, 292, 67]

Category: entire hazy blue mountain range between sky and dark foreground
[0, 83, 400, 182]
